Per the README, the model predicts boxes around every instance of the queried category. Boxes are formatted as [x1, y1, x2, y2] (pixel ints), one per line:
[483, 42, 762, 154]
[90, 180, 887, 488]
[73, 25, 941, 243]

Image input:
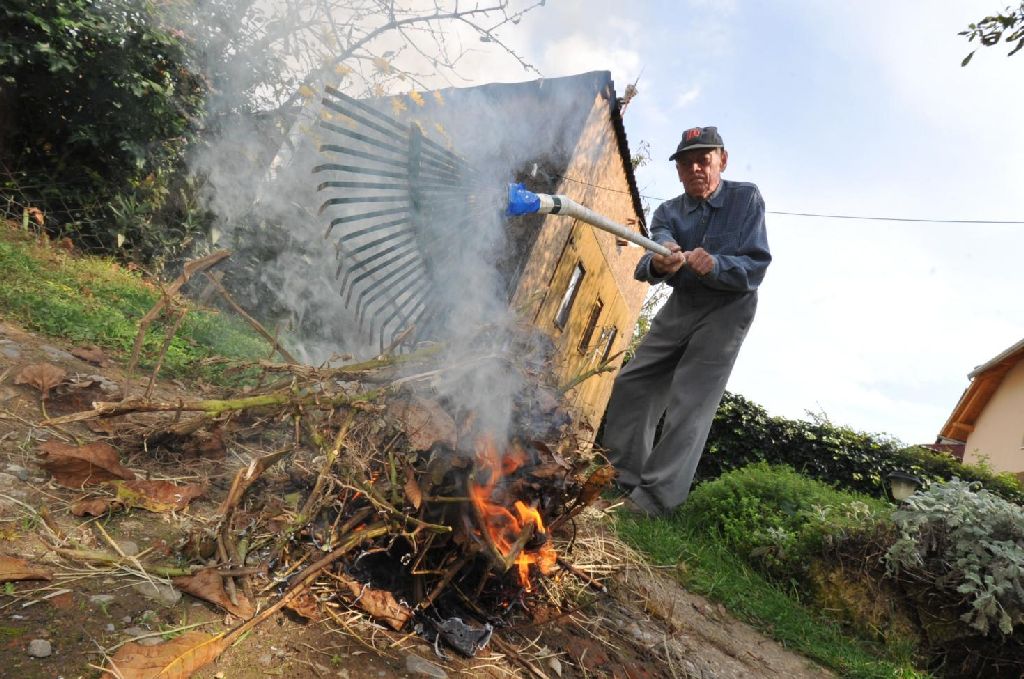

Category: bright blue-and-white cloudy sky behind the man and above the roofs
[434, 0, 1024, 443]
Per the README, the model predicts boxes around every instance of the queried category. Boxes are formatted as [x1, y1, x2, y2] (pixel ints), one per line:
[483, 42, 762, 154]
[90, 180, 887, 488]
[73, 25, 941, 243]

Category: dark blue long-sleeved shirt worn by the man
[634, 179, 771, 292]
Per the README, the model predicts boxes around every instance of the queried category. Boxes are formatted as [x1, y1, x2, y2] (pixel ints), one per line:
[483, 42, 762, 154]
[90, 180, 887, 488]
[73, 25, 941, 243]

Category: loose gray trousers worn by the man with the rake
[603, 290, 758, 514]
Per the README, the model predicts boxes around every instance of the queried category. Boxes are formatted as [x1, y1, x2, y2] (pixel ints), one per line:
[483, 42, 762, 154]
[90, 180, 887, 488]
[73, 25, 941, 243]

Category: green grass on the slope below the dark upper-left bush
[0, 225, 270, 379]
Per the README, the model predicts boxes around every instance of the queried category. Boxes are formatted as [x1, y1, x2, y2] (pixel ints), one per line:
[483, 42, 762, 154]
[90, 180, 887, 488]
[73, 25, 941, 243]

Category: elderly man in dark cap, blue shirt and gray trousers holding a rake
[603, 127, 771, 515]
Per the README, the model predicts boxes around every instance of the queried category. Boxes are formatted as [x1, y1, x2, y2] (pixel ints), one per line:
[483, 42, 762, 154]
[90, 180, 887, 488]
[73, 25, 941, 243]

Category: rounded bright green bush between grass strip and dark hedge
[683, 462, 891, 581]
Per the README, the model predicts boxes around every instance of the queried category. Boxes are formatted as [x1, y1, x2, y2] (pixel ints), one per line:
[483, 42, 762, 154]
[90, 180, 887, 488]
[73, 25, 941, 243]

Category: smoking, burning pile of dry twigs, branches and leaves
[51, 321, 612, 676]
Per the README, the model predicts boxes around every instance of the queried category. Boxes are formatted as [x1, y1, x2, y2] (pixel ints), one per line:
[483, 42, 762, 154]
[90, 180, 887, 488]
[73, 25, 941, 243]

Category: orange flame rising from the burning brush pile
[469, 437, 558, 592]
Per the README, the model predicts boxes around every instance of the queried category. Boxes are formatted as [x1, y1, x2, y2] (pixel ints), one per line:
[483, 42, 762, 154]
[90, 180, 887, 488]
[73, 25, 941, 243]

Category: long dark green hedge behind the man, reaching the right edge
[696, 393, 1024, 503]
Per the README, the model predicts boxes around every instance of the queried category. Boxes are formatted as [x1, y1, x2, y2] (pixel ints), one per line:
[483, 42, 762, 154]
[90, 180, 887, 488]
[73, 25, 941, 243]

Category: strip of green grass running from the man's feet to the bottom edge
[617, 513, 929, 679]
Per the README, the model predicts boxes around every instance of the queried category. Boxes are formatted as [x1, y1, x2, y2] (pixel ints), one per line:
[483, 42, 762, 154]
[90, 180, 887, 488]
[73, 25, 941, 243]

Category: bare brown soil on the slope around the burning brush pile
[0, 322, 831, 679]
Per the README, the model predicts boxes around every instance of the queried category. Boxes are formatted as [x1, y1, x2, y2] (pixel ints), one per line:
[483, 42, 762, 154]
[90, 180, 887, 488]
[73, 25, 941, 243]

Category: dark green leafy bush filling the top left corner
[0, 0, 205, 261]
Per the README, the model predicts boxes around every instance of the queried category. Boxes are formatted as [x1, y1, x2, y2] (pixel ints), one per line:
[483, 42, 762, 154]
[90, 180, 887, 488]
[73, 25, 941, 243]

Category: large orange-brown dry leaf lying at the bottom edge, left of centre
[101, 631, 227, 679]
